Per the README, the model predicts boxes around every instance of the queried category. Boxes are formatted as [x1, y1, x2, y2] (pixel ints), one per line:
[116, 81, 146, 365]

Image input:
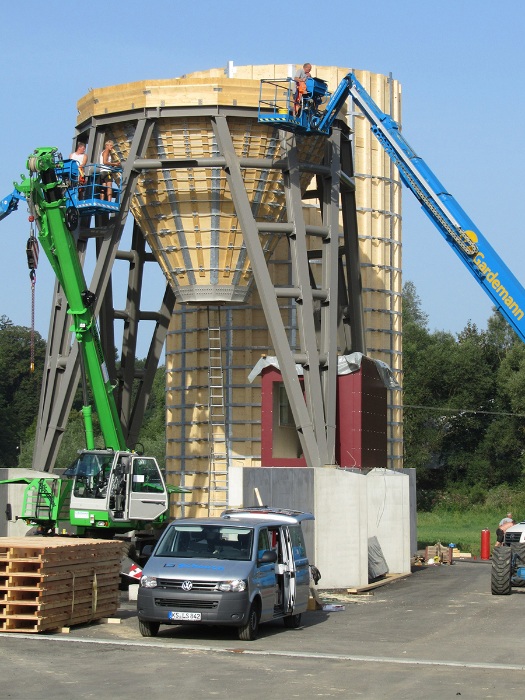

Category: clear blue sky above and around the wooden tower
[0, 0, 525, 355]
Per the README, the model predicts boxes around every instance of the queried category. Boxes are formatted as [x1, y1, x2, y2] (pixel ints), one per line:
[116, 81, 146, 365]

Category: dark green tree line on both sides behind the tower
[0, 282, 525, 508]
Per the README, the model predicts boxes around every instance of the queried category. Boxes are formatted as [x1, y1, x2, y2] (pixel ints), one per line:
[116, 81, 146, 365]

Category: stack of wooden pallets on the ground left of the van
[0, 537, 124, 632]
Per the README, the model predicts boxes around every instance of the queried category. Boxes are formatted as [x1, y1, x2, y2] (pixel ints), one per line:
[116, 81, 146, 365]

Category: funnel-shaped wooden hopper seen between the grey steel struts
[101, 112, 324, 303]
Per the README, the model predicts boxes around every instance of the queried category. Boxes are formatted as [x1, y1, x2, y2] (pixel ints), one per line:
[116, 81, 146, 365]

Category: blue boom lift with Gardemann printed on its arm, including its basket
[258, 73, 525, 341]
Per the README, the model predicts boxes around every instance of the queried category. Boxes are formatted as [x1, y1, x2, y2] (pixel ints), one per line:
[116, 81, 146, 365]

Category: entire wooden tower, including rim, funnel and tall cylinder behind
[72, 65, 402, 515]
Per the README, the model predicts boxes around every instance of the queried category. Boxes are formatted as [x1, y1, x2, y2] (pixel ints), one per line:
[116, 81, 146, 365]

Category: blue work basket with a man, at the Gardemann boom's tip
[258, 78, 330, 134]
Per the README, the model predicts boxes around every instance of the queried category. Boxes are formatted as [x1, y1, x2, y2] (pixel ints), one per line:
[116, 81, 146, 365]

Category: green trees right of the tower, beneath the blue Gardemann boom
[403, 283, 525, 494]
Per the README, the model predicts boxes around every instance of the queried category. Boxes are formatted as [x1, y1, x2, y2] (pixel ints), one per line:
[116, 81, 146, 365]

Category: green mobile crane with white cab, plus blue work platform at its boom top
[0, 148, 187, 556]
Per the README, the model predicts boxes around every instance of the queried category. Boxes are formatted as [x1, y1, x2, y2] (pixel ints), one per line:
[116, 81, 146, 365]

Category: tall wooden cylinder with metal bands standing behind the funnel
[167, 65, 402, 516]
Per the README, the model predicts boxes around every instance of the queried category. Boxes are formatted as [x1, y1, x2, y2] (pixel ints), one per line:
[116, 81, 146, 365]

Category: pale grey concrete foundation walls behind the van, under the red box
[230, 467, 415, 588]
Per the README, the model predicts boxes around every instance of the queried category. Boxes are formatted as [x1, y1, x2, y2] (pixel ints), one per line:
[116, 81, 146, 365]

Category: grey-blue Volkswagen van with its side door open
[137, 507, 314, 640]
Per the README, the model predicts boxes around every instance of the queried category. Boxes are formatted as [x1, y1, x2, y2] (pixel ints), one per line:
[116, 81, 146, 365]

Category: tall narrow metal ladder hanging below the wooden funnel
[208, 306, 228, 515]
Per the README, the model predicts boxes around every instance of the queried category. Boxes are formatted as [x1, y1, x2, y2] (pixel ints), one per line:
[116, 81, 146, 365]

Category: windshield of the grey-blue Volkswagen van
[155, 524, 253, 561]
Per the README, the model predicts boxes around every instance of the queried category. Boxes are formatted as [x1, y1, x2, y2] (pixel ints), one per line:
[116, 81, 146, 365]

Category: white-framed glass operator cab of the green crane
[63, 450, 168, 528]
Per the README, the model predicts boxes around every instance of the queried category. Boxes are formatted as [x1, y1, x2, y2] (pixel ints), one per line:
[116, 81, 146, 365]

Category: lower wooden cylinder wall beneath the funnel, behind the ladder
[166, 254, 292, 517]
